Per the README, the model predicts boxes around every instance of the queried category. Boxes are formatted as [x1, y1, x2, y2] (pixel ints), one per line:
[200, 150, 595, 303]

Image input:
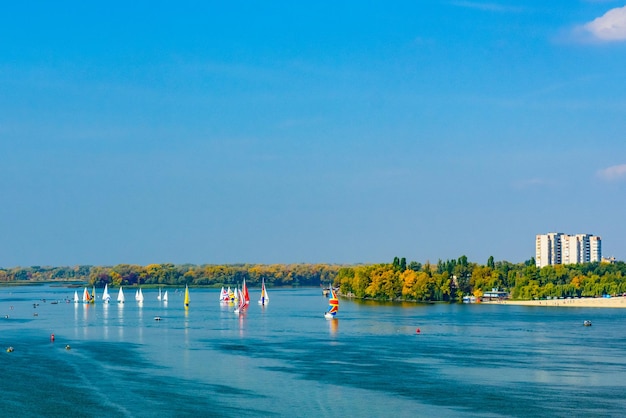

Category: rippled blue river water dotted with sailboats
[0, 285, 626, 417]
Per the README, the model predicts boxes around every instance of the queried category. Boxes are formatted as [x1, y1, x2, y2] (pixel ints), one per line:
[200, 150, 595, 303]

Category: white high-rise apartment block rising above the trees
[535, 232, 602, 267]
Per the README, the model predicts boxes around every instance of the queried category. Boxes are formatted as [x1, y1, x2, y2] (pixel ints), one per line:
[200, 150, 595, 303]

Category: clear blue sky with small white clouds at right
[0, 0, 626, 267]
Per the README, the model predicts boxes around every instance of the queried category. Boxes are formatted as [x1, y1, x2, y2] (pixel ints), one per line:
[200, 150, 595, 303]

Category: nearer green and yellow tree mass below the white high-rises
[334, 256, 626, 301]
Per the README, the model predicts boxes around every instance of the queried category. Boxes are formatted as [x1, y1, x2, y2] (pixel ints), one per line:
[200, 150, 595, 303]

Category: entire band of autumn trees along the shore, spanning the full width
[0, 256, 626, 302]
